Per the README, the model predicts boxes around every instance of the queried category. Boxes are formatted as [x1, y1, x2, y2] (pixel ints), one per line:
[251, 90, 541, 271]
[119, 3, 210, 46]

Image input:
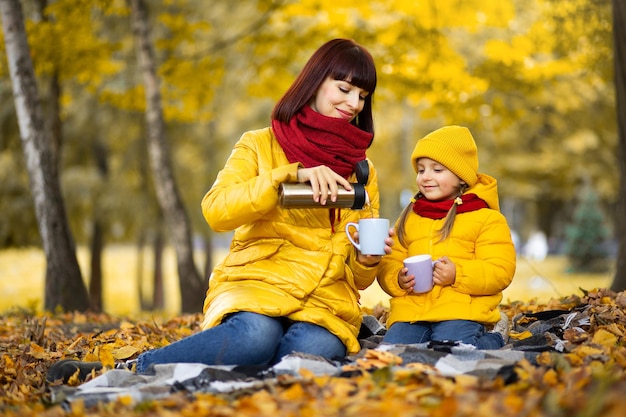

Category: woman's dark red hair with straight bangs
[272, 39, 376, 134]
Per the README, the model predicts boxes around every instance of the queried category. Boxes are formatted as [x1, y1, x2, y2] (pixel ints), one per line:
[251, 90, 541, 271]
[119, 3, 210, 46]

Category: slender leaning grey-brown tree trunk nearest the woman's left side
[129, 0, 205, 313]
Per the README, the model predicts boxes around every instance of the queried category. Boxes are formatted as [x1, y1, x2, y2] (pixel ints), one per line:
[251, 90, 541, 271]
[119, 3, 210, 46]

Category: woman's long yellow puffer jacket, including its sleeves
[202, 128, 379, 353]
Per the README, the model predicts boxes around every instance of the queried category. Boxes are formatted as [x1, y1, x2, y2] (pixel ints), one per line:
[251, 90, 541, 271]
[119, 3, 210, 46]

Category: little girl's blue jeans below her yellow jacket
[383, 320, 504, 349]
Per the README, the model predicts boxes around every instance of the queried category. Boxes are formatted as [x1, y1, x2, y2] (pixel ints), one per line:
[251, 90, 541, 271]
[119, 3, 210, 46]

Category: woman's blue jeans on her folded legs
[137, 312, 346, 373]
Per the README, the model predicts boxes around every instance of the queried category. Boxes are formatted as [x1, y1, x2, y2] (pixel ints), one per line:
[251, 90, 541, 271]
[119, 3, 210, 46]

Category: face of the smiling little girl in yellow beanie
[417, 158, 463, 201]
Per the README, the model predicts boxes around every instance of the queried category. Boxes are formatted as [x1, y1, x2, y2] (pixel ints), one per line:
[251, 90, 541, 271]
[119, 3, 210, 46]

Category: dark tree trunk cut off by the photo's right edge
[611, 0, 626, 291]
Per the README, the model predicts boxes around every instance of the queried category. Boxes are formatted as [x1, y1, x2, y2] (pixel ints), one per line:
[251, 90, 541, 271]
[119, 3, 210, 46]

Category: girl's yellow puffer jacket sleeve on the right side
[453, 211, 516, 295]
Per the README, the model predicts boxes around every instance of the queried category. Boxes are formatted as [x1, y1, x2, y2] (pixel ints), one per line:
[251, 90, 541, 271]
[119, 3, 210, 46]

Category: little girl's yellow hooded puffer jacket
[378, 174, 516, 327]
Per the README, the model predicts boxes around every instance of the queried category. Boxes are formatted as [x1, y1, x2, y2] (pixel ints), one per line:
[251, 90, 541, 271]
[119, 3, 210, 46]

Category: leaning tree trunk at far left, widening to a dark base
[0, 0, 89, 311]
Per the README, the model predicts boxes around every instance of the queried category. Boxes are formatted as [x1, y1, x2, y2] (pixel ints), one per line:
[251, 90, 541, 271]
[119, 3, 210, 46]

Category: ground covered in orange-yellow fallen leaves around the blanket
[0, 289, 626, 417]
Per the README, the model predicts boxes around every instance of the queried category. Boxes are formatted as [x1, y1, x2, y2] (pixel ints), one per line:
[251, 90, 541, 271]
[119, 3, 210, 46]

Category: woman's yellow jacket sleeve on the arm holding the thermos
[201, 129, 299, 232]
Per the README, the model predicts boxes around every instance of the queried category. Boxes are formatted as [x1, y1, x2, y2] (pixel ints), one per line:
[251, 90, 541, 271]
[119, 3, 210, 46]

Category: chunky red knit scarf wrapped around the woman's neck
[272, 106, 373, 178]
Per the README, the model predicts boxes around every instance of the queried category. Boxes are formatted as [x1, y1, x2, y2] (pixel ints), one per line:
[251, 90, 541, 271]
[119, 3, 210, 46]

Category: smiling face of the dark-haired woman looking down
[311, 77, 369, 121]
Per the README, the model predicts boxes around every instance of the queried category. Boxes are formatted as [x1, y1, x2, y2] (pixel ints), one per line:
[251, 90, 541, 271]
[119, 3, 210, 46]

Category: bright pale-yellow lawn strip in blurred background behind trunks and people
[0, 245, 613, 317]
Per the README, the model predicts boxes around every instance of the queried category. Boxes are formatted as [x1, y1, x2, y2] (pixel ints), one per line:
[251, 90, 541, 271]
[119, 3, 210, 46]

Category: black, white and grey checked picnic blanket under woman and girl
[50, 308, 589, 409]
